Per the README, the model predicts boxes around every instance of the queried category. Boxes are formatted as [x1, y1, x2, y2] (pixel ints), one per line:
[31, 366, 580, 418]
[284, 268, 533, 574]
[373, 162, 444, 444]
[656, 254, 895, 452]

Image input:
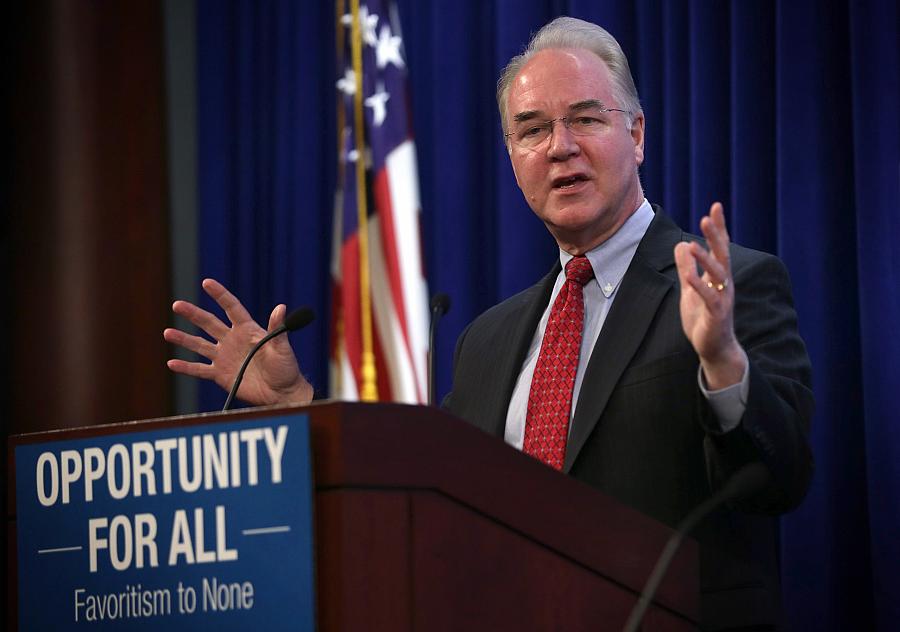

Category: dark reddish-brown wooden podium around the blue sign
[7, 402, 699, 632]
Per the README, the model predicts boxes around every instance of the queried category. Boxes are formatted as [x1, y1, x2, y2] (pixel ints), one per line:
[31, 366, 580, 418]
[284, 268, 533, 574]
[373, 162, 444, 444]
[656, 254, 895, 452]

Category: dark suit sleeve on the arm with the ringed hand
[698, 253, 814, 514]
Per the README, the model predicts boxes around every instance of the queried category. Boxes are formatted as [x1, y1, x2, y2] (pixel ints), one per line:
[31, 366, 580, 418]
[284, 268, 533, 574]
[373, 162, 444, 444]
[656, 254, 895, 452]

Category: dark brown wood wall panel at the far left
[10, 0, 171, 433]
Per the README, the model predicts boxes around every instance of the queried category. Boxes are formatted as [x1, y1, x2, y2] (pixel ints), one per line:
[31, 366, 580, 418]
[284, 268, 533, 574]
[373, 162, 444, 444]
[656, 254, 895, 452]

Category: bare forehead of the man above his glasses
[506, 49, 613, 117]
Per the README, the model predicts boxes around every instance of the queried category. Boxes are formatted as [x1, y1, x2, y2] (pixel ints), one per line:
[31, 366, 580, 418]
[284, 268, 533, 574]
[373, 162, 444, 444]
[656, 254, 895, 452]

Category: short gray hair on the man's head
[497, 17, 642, 133]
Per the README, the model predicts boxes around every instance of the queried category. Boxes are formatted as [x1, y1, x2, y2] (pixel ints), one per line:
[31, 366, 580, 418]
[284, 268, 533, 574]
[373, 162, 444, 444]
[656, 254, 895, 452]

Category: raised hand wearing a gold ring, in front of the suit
[675, 202, 746, 390]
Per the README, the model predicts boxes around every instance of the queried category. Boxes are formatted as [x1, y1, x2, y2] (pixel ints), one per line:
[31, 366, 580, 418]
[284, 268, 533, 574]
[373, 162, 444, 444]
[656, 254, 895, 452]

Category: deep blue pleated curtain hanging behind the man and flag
[197, 0, 900, 630]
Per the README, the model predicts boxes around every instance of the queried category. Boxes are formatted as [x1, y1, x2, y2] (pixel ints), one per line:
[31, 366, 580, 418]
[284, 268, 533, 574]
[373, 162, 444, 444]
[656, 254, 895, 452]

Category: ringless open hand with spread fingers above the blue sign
[163, 279, 313, 406]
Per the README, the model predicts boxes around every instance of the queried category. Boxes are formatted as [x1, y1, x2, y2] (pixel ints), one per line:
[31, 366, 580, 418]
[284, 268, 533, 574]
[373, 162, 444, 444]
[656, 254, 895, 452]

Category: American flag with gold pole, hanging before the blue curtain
[331, 0, 429, 403]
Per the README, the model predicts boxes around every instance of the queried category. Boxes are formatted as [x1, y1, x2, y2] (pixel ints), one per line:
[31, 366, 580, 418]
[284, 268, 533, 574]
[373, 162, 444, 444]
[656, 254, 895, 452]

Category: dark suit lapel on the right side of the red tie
[563, 208, 682, 472]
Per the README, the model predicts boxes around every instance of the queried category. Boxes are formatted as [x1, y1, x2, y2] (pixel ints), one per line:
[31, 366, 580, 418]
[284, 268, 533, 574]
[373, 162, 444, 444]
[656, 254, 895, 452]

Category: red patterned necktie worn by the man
[522, 255, 594, 470]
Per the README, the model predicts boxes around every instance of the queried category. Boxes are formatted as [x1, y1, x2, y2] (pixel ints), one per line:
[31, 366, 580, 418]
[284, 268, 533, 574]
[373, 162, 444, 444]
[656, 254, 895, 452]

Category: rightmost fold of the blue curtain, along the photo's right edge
[845, 2, 900, 630]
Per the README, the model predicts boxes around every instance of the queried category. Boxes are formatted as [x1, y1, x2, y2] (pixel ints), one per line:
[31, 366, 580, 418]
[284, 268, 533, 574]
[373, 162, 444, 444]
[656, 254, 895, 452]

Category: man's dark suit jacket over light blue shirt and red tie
[445, 209, 813, 630]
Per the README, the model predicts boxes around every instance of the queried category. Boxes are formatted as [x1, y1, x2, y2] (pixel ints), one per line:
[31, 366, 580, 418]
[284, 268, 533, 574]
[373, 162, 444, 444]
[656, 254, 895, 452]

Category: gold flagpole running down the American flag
[350, 0, 378, 402]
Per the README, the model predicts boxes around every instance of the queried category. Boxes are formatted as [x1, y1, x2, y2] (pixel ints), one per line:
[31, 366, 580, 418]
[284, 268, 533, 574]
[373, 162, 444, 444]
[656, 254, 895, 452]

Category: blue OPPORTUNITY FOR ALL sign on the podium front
[15, 415, 315, 631]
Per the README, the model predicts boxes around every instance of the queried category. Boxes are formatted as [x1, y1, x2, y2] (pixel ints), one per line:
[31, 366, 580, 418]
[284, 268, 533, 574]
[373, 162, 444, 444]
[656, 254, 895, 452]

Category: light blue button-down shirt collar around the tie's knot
[559, 198, 654, 298]
